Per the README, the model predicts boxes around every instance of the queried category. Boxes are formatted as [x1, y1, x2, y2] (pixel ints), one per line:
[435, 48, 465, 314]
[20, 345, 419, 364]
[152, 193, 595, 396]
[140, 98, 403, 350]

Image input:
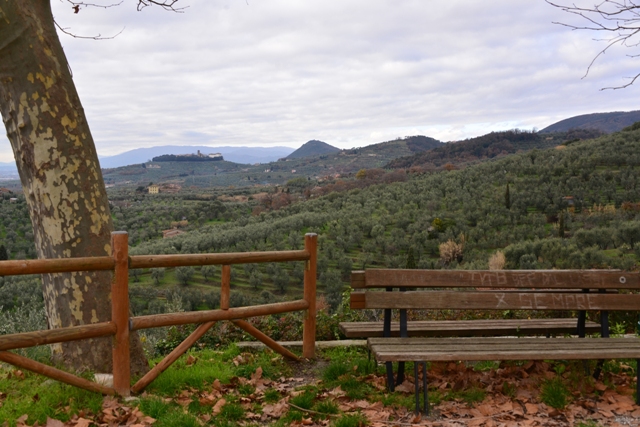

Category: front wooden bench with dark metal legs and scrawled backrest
[351, 269, 640, 412]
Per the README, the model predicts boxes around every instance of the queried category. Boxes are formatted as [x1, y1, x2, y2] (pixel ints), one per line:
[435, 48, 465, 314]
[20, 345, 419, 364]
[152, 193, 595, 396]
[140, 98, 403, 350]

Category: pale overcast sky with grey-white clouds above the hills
[0, 0, 640, 162]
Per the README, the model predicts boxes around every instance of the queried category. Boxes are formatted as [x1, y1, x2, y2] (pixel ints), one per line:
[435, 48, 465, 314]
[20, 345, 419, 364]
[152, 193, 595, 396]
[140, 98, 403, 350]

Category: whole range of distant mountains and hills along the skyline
[0, 111, 640, 180]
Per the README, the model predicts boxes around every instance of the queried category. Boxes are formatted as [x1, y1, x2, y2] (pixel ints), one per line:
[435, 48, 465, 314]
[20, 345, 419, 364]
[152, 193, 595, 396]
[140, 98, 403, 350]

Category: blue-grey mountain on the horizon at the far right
[540, 110, 640, 133]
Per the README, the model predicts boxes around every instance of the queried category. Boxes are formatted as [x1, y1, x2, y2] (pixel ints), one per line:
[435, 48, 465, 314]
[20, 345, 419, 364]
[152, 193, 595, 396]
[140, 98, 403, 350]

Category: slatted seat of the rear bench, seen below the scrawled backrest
[340, 318, 600, 338]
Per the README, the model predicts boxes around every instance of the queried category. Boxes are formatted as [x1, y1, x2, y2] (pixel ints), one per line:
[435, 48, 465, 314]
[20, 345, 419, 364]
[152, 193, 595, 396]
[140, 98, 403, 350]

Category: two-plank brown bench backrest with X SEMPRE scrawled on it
[351, 269, 640, 310]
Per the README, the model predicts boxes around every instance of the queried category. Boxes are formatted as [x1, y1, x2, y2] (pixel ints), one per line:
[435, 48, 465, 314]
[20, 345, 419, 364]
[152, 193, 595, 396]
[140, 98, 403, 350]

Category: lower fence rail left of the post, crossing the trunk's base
[0, 322, 116, 351]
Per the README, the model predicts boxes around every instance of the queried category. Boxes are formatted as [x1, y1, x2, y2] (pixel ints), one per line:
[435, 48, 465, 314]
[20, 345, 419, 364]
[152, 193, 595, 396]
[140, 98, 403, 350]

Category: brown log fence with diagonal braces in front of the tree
[0, 231, 317, 396]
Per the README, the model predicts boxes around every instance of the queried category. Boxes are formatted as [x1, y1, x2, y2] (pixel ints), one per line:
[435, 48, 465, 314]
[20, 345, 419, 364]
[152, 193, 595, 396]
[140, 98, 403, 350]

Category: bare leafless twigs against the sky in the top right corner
[545, 0, 640, 90]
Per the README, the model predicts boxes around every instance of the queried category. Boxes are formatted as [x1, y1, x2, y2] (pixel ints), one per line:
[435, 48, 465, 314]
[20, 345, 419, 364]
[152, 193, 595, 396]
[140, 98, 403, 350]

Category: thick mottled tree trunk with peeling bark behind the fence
[0, 0, 147, 372]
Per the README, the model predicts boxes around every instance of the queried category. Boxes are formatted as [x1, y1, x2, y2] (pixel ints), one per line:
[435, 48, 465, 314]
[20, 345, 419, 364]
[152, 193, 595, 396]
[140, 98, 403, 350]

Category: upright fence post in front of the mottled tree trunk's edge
[111, 231, 131, 396]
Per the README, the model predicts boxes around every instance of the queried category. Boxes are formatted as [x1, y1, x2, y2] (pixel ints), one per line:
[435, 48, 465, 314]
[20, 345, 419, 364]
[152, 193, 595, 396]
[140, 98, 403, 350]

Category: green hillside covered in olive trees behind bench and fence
[0, 125, 640, 324]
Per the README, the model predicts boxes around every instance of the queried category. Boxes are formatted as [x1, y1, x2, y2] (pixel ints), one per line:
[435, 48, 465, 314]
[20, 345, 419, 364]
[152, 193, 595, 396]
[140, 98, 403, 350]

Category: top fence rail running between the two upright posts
[131, 251, 309, 268]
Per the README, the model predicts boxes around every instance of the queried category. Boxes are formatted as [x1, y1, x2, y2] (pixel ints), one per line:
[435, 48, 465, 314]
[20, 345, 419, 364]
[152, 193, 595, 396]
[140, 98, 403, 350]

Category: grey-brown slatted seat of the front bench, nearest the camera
[367, 337, 640, 362]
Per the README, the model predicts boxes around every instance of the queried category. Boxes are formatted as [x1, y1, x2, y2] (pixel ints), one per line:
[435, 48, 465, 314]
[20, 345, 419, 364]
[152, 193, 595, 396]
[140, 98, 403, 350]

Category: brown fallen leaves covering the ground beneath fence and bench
[6, 357, 640, 427]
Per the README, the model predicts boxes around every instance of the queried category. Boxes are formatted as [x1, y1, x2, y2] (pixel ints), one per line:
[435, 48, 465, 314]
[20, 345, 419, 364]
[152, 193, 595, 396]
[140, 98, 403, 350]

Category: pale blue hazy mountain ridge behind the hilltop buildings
[98, 145, 294, 168]
